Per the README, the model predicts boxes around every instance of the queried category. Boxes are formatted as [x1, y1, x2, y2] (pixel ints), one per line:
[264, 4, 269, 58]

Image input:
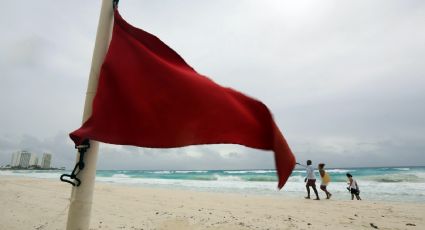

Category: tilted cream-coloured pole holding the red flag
[66, 0, 113, 230]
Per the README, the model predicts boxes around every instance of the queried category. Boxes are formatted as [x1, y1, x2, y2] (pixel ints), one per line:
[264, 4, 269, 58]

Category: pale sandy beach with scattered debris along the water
[0, 176, 425, 229]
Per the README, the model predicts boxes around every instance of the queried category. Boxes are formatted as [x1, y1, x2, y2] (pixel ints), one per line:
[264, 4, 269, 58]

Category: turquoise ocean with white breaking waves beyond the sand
[0, 167, 425, 203]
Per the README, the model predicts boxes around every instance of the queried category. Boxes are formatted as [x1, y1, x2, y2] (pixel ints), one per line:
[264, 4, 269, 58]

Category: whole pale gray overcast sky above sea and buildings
[0, 0, 425, 169]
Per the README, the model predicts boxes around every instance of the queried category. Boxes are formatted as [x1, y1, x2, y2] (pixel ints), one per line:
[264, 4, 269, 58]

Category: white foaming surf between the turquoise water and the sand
[0, 170, 425, 204]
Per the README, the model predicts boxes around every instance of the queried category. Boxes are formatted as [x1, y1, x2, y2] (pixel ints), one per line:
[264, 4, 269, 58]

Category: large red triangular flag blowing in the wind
[70, 10, 295, 188]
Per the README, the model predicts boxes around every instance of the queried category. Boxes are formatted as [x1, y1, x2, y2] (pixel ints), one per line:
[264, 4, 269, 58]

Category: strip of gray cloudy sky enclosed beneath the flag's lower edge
[98, 145, 274, 170]
